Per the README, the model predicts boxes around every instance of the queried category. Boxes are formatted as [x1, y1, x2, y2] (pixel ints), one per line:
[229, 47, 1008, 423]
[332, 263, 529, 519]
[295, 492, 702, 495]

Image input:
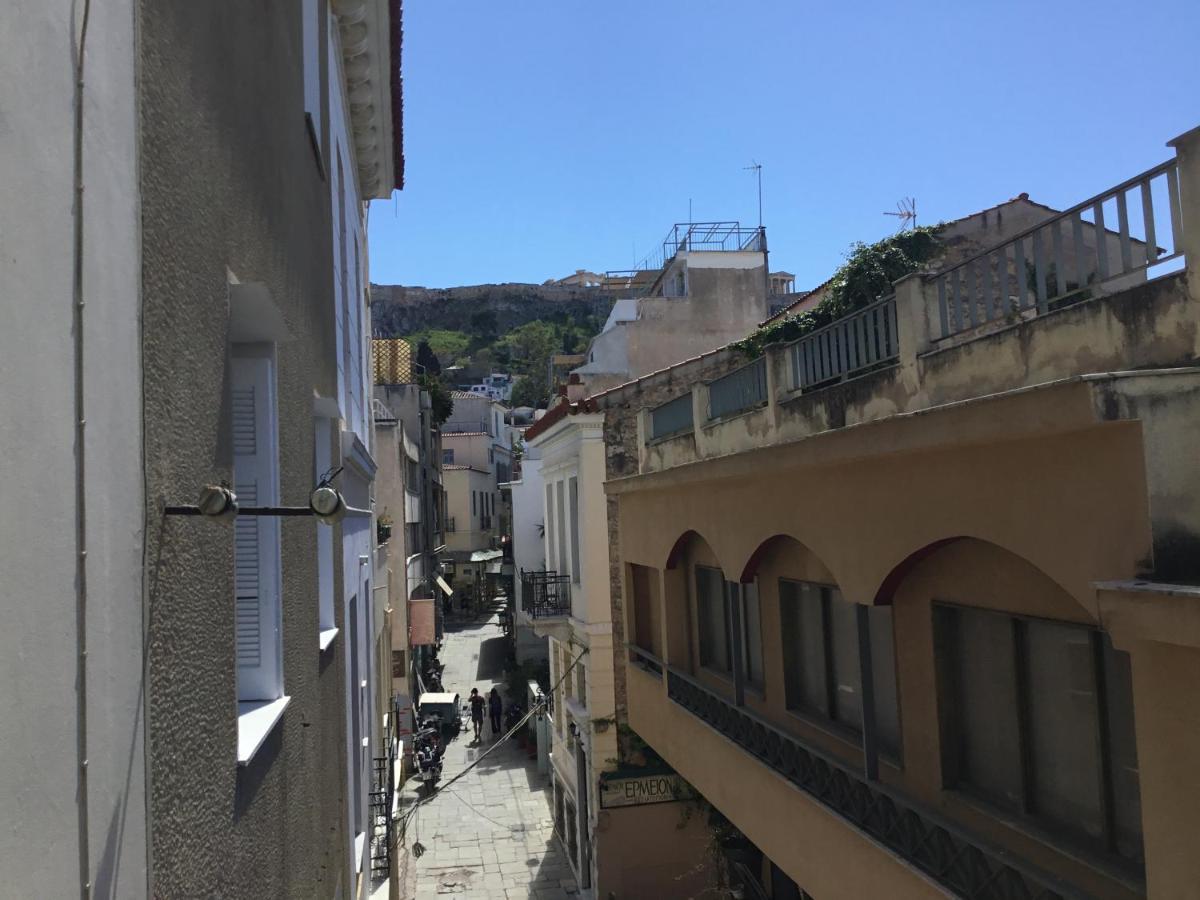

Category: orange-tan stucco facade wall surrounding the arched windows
[610, 396, 1150, 896]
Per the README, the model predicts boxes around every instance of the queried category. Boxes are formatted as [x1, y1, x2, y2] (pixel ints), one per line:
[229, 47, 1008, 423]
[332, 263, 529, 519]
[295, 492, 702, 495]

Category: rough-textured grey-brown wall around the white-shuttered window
[139, 2, 350, 898]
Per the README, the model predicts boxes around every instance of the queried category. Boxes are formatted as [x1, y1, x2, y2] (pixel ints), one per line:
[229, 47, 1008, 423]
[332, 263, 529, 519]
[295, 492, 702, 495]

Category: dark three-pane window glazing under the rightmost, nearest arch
[935, 606, 1142, 863]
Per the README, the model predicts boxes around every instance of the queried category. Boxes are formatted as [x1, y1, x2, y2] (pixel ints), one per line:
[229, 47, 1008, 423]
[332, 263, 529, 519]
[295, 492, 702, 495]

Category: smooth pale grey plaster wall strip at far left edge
[0, 0, 148, 898]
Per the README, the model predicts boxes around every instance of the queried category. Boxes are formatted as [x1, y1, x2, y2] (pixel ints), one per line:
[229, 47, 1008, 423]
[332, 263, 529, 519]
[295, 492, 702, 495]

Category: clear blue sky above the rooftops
[370, 0, 1200, 289]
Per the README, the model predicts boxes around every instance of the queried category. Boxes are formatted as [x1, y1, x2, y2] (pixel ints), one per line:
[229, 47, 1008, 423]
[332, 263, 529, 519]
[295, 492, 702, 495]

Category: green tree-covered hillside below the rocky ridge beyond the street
[371, 284, 612, 406]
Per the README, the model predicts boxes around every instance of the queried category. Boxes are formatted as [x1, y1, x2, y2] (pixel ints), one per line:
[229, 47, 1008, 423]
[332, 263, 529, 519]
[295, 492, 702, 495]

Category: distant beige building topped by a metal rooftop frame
[574, 222, 769, 392]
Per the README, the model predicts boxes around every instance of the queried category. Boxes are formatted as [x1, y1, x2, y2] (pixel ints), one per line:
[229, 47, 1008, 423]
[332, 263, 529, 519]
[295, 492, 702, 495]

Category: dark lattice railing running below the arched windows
[667, 667, 1081, 900]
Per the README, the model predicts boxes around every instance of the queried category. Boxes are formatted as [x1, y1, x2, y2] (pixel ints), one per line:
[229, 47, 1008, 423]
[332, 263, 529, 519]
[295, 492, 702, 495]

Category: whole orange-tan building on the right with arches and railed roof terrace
[585, 130, 1200, 900]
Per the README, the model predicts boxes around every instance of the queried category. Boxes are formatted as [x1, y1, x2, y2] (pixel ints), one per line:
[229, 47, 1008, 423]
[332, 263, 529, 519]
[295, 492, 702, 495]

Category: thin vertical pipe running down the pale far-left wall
[71, 0, 91, 900]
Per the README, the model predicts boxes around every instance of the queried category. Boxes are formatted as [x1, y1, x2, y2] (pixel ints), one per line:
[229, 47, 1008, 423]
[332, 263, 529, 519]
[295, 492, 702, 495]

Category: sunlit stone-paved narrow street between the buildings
[401, 610, 578, 900]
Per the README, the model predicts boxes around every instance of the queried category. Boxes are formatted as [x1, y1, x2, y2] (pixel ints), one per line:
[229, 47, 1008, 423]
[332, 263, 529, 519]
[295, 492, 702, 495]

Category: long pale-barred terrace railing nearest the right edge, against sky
[935, 160, 1183, 337]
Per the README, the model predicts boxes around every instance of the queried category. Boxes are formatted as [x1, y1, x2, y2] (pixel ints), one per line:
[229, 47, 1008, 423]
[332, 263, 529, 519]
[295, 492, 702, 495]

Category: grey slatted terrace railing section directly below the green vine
[791, 296, 900, 389]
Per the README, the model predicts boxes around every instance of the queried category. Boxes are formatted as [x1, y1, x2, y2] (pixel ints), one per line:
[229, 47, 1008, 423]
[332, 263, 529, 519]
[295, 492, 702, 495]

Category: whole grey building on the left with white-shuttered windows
[0, 0, 403, 898]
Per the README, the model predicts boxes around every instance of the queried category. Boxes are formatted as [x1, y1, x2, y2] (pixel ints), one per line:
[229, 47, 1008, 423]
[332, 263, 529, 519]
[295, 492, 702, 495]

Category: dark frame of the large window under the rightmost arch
[931, 600, 1145, 877]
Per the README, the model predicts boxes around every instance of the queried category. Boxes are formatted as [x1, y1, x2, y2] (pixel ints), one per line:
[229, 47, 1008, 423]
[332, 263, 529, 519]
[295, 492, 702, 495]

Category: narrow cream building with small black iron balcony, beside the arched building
[514, 396, 707, 896]
